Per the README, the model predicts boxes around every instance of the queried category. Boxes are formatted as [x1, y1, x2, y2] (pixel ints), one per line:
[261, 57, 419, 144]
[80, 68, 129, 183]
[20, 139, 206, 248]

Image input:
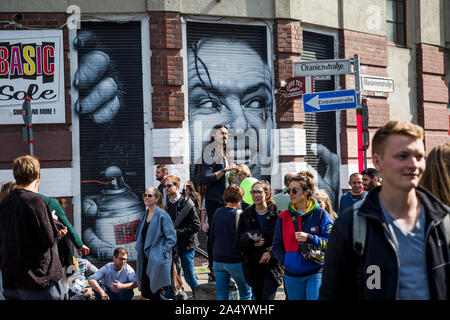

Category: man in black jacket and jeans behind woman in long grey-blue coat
[165, 175, 200, 294]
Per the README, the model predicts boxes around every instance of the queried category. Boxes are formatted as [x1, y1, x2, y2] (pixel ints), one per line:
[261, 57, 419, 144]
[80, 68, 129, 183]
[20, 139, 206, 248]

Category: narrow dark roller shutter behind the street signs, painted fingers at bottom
[301, 31, 339, 208]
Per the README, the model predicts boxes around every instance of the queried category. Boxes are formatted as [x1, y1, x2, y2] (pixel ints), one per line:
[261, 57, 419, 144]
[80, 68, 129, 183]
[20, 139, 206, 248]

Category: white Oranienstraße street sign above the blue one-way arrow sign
[294, 59, 352, 77]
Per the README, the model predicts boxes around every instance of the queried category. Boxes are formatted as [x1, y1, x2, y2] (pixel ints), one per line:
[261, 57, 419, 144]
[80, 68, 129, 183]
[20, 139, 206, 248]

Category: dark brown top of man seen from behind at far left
[0, 189, 63, 290]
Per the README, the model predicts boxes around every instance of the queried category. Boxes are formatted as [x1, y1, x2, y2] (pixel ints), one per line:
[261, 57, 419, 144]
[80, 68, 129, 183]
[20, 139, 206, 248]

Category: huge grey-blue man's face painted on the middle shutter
[188, 38, 273, 175]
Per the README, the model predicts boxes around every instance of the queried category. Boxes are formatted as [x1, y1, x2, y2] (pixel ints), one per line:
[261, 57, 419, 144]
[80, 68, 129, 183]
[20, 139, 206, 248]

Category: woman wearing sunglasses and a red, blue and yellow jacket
[272, 171, 333, 300]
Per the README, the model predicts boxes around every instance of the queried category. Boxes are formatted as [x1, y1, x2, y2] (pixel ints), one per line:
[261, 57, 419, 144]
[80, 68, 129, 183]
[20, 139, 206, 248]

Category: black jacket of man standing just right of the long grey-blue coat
[166, 197, 201, 252]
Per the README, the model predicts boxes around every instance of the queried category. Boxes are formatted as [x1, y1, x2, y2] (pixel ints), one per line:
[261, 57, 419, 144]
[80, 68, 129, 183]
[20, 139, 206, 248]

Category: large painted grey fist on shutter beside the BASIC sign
[73, 32, 121, 123]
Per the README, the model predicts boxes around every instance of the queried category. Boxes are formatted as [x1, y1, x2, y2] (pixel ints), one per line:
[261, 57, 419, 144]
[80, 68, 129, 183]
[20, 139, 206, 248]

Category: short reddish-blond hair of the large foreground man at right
[372, 121, 423, 155]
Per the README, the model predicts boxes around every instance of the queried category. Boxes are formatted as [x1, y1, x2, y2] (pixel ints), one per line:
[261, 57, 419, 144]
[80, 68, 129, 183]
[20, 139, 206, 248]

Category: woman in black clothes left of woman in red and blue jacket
[237, 180, 283, 300]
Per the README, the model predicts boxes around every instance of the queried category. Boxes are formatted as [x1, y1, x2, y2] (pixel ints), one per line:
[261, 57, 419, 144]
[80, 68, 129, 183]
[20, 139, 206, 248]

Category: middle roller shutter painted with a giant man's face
[186, 21, 273, 251]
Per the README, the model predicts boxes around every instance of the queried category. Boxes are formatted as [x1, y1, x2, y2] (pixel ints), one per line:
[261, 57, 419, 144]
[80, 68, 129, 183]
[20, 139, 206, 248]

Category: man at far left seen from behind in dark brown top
[0, 156, 65, 300]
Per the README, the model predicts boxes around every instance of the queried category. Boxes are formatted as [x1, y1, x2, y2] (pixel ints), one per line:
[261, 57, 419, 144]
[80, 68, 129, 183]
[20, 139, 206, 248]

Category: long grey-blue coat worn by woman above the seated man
[136, 207, 177, 293]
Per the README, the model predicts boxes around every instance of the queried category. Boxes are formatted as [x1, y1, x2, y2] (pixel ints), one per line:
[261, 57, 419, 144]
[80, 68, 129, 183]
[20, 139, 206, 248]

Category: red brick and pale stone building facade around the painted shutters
[0, 1, 450, 262]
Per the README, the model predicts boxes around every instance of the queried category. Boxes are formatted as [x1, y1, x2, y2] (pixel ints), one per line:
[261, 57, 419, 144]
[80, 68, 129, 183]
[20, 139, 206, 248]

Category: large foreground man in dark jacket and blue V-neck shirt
[320, 121, 450, 300]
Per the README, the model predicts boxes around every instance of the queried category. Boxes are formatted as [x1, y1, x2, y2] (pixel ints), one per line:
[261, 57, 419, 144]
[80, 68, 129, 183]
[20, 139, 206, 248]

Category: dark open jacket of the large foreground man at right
[319, 187, 450, 300]
